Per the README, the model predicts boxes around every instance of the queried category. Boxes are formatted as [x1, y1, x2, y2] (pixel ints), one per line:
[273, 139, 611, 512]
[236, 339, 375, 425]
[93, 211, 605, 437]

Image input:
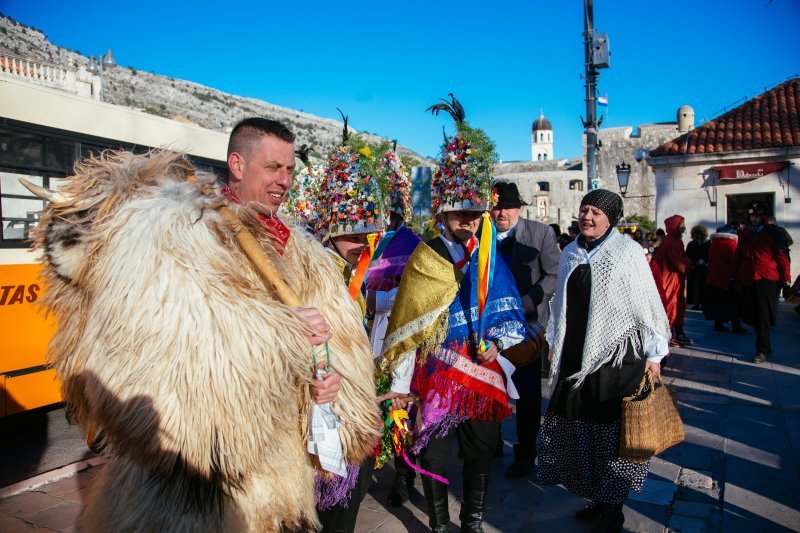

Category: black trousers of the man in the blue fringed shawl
[419, 420, 500, 476]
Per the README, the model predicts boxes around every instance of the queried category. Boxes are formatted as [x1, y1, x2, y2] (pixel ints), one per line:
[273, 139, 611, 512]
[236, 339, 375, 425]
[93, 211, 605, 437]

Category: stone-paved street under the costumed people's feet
[0, 304, 800, 533]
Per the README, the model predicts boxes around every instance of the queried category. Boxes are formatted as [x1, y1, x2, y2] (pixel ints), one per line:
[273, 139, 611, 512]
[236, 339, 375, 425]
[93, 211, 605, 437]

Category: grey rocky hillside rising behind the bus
[0, 13, 431, 165]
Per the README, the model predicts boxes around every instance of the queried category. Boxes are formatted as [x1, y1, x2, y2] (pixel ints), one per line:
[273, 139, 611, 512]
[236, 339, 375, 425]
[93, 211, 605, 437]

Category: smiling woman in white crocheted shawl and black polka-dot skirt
[539, 189, 669, 532]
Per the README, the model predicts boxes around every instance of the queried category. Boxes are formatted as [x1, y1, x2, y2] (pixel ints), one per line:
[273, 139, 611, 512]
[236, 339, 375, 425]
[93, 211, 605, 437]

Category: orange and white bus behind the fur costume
[0, 74, 228, 417]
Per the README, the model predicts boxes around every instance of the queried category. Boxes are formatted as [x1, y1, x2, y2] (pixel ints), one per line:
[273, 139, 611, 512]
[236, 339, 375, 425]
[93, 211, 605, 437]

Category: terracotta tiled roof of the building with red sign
[650, 78, 800, 157]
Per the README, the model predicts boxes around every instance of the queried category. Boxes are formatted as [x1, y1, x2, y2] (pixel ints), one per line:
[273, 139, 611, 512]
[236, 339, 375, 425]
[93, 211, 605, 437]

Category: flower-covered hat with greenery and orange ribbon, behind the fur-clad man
[317, 111, 391, 238]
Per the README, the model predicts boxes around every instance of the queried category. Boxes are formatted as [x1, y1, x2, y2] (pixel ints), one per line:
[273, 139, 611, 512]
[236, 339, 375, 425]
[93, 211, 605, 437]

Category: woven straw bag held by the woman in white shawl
[619, 372, 686, 463]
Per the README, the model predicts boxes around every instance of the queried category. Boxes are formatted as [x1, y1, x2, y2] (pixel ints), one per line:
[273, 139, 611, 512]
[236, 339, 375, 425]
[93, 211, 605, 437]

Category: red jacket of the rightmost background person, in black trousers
[736, 224, 791, 287]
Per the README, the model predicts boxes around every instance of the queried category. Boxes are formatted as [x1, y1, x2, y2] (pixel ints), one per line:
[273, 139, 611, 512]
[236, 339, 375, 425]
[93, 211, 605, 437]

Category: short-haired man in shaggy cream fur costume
[29, 119, 380, 532]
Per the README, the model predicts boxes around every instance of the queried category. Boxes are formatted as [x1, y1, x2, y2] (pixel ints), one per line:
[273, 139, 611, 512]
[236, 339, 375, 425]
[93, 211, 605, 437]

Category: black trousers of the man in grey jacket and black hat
[511, 360, 542, 460]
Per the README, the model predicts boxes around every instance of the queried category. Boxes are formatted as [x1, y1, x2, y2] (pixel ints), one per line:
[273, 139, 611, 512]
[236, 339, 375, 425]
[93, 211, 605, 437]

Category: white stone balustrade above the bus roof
[0, 54, 100, 100]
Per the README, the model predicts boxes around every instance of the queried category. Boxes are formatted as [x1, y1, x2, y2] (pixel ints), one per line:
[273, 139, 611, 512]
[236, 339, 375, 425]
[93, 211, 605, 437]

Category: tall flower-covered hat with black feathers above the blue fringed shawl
[426, 93, 497, 215]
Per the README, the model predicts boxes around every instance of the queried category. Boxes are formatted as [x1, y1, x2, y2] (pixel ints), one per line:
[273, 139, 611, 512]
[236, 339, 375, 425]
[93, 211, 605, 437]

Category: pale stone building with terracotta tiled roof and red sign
[647, 78, 800, 276]
